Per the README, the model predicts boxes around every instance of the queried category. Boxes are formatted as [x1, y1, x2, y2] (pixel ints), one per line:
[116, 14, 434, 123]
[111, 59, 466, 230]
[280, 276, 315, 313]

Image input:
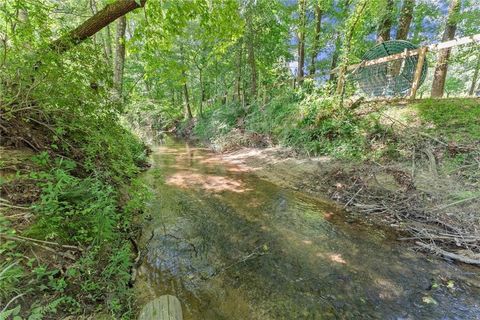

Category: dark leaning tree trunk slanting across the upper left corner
[50, 0, 147, 53]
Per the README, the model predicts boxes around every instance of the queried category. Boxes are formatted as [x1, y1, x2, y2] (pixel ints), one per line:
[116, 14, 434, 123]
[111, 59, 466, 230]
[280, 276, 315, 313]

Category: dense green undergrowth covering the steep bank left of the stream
[0, 31, 148, 319]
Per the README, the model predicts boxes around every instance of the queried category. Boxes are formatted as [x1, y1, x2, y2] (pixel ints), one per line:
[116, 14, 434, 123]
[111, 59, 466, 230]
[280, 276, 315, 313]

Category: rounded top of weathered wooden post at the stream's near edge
[138, 295, 183, 320]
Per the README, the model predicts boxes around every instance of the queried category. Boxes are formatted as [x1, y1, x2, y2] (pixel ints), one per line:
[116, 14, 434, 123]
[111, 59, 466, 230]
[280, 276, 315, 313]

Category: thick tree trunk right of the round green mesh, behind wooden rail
[431, 0, 461, 97]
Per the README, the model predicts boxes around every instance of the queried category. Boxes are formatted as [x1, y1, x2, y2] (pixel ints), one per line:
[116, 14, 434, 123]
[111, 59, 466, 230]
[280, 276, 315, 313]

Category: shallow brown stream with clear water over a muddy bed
[136, 140, 480, 319]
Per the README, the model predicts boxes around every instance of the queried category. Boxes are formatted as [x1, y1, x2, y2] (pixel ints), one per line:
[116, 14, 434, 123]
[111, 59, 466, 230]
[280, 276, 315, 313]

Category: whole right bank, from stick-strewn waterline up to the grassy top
[193, 100, 480, 266]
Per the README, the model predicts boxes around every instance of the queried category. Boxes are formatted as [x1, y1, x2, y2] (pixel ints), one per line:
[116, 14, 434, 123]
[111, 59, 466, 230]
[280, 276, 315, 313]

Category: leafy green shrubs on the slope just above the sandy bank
[189, 86, 380, 158]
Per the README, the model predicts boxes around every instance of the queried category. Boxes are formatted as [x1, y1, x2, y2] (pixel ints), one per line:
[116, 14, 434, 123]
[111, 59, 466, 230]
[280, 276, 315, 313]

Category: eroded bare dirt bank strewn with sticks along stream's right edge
[213, 147, 480, 266]
